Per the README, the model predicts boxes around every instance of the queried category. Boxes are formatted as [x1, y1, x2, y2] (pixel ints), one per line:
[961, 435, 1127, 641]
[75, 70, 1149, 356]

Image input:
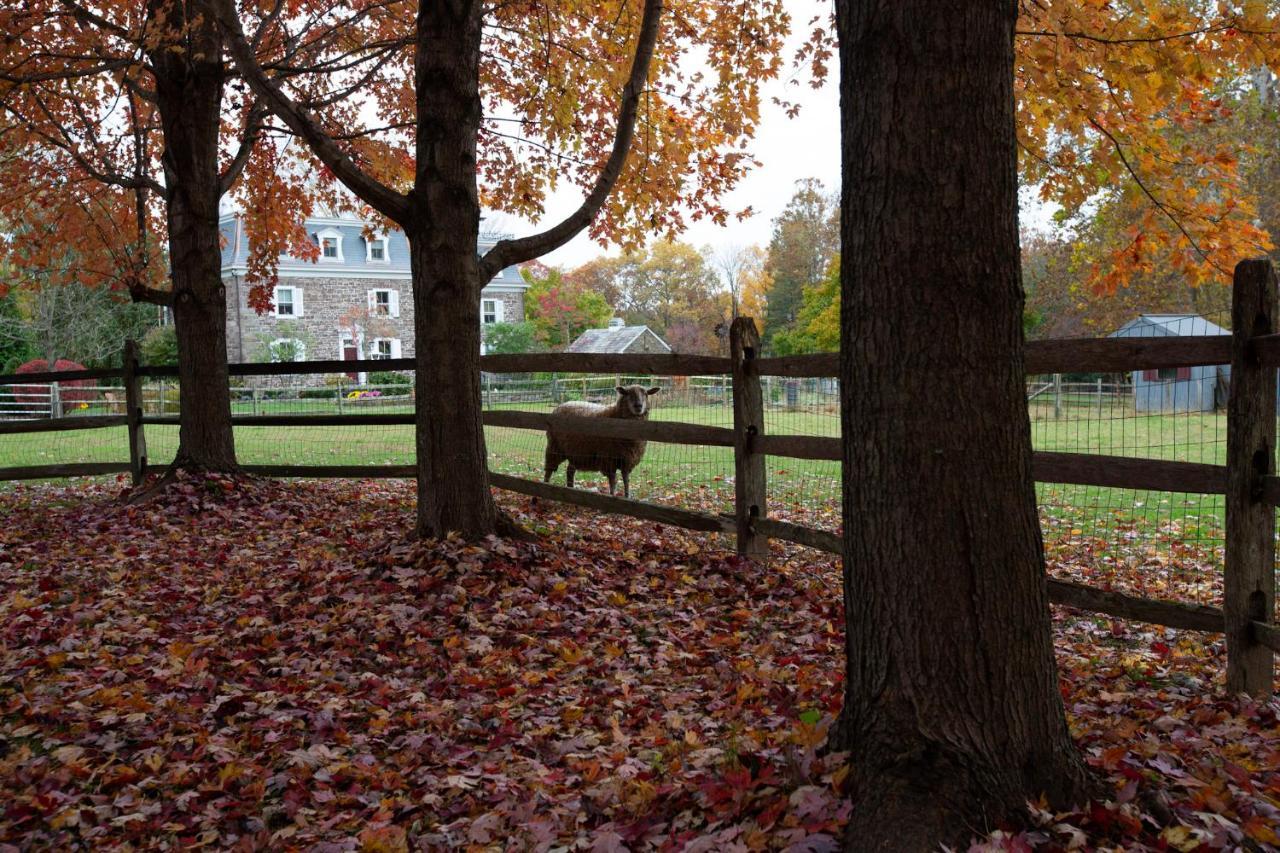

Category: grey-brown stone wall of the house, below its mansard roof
[227, 277, 525, 362]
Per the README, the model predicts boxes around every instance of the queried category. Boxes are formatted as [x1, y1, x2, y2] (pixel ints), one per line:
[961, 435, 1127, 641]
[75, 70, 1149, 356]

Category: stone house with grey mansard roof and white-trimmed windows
[219, 213, 529, 362]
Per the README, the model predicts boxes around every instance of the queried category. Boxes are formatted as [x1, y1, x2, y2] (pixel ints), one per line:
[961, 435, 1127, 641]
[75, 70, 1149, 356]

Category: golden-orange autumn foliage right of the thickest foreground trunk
[1016, 0, 1280, 292]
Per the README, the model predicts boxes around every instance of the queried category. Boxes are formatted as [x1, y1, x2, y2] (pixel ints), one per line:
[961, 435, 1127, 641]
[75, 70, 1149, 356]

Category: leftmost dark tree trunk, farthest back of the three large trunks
[150, 0, 236, 471]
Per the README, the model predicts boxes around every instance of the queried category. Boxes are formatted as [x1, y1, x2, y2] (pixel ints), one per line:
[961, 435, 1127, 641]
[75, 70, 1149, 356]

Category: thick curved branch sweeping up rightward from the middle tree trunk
[478, 0, 662, 282]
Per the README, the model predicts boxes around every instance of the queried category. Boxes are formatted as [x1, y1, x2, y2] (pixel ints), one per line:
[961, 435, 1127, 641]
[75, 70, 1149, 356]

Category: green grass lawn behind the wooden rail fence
[0, 400, 1226, 540]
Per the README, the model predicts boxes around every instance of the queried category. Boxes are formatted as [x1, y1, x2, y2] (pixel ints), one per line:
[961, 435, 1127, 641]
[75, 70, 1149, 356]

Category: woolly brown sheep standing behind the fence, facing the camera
[543, 386, 662, 497]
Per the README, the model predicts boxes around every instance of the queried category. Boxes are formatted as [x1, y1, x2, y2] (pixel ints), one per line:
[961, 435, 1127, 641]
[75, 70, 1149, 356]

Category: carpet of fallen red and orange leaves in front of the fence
[0, 478, 1280, 850]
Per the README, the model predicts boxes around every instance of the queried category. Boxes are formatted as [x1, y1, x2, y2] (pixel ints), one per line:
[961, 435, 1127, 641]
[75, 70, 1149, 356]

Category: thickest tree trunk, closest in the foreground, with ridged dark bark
[835, 0, 1087, 850]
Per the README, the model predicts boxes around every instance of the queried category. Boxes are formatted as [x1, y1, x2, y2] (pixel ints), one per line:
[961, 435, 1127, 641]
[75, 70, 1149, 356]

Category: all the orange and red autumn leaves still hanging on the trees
[0, 0, 1280, 304]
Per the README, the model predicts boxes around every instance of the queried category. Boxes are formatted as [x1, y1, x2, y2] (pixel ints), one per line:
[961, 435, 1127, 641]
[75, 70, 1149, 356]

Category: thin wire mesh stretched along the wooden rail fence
[0, 371, 1226, 552]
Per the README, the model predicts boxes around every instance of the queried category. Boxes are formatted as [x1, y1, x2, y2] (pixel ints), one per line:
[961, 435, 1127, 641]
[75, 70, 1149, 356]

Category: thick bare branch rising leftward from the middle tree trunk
[210, 0, 410, 225]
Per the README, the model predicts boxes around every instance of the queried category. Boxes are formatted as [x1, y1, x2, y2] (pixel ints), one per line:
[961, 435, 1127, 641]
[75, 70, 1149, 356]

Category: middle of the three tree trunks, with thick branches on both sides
[406, 0, 498, 538]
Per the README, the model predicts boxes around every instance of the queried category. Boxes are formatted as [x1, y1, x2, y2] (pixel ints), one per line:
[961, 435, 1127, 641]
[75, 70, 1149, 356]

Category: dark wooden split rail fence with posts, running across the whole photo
[0, 261, 1280, 695]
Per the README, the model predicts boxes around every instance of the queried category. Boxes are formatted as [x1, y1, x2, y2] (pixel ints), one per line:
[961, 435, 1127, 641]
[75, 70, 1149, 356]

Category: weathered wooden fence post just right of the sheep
[728, 316, 769, 564]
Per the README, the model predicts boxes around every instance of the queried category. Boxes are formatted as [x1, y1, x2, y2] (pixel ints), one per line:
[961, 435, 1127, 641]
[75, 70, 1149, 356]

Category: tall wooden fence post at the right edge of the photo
[1222, 259, 1277, 697]
